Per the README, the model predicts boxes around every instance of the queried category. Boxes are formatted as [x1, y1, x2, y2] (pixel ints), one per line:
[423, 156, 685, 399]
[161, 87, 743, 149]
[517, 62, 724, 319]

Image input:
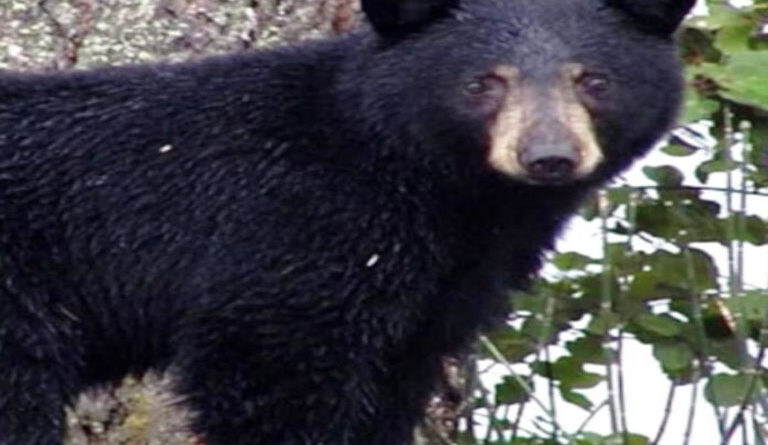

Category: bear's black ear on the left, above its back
[362, 0, 459, 36]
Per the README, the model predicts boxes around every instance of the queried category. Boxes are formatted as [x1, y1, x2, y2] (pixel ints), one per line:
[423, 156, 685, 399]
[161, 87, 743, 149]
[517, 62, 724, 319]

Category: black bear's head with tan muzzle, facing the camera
[356, 0, 694, 185]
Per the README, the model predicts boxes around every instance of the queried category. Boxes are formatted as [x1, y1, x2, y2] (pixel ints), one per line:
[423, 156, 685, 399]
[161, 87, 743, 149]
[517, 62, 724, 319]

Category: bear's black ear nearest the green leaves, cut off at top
[606, 0, 696, 34]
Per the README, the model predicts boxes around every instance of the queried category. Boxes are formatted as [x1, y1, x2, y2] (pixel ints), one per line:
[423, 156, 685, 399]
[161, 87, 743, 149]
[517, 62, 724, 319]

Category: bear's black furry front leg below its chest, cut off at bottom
[177, 303, 433, 445]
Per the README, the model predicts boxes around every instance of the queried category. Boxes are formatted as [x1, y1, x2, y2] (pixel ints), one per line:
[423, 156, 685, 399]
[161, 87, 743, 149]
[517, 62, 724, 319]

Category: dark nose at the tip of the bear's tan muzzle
[520, 145, 579, 183]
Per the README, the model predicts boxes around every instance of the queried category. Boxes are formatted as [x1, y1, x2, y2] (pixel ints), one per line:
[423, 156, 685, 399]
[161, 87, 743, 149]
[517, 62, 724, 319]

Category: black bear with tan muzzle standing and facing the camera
[0, 0, 693, 445]
